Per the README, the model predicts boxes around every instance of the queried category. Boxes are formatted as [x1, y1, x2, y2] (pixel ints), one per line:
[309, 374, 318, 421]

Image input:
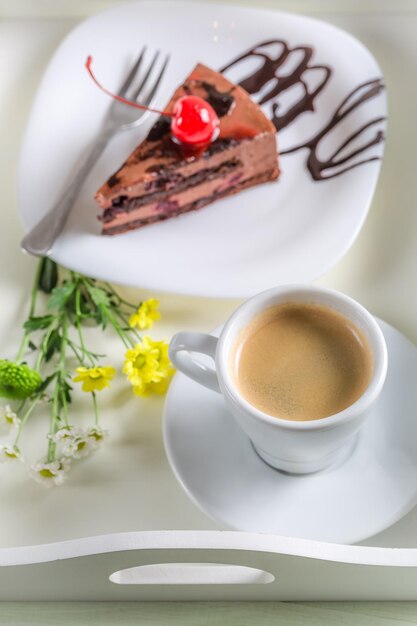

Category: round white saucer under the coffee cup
[164, 321, 417, 543]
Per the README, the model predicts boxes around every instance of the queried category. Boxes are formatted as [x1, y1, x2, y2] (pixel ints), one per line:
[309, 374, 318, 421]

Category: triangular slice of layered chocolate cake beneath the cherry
[96, 65, 279, 235]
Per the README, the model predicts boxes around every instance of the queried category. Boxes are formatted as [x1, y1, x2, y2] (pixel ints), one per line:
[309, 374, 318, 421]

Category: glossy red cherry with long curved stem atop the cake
[85, 56, 220, 147]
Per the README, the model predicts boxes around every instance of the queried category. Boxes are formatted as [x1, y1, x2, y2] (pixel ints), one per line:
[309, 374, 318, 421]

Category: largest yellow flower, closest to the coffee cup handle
[123, 337, 174, 396]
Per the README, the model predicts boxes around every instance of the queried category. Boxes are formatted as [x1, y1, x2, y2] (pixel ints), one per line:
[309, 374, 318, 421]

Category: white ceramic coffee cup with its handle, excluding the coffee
[169, 285, 388, 474]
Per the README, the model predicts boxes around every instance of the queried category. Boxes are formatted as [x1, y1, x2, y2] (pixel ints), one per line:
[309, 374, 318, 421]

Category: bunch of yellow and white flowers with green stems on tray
[0, 258, 174, 486]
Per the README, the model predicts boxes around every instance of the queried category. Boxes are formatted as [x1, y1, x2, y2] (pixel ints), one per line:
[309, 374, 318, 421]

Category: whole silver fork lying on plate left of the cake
[21, 46, 169, 256]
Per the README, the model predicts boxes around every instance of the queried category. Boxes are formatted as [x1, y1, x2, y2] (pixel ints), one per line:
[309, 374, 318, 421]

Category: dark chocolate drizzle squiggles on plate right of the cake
[220, 39, 385, 181]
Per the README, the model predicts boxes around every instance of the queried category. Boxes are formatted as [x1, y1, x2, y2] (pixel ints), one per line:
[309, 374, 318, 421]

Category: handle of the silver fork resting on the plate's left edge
[21, 131, 112, 257]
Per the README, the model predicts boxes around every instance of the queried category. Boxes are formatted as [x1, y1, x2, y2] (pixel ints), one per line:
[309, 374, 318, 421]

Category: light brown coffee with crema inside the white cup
[232, 303, 373, 421]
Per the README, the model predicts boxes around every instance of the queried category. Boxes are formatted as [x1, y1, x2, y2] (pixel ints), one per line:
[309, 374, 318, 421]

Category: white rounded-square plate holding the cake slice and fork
[18, 2, 386, 297]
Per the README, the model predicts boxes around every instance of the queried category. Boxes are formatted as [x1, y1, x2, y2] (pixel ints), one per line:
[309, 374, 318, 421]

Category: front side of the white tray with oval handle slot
[4, 531, 417, 601]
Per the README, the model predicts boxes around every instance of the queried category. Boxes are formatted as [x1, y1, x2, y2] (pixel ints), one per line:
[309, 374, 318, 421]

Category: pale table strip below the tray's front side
[0, 602, 417, 626]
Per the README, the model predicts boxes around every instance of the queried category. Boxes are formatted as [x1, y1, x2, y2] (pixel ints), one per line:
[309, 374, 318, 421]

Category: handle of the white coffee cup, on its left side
[169, 333, 220, 393]
